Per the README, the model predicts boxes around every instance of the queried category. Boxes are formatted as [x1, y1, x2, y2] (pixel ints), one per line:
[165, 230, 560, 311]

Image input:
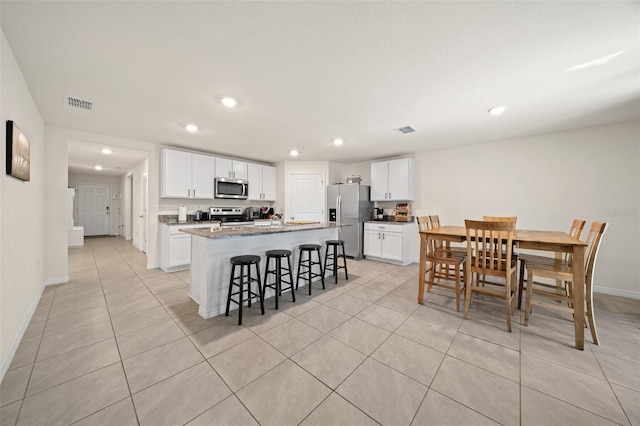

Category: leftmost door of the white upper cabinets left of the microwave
[160, 149, 191, 198]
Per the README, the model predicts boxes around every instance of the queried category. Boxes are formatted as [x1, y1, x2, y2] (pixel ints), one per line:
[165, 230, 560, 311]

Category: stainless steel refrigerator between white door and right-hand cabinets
[327, 183, 373, 259]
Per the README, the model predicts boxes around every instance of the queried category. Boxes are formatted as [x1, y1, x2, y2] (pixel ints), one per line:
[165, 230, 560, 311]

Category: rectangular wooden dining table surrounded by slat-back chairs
[418, 226, 587, 350]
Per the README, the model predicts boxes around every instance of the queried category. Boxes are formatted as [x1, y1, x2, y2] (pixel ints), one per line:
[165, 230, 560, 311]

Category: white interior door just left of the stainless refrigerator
[287, 173, 325, 222]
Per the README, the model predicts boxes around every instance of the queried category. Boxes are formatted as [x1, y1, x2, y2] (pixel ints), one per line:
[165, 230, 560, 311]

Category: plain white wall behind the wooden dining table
[345, 120, 640, 298]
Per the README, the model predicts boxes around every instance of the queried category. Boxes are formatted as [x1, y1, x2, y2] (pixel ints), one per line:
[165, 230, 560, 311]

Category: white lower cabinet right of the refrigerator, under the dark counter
[364, 222, 418, 265]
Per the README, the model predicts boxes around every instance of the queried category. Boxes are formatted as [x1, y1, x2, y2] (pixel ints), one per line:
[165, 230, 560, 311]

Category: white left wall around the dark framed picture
[0, 32, 45, 380]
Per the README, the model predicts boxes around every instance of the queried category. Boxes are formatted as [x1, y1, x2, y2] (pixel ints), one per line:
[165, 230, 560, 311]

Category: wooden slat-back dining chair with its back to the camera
[463, 219, 518, 332]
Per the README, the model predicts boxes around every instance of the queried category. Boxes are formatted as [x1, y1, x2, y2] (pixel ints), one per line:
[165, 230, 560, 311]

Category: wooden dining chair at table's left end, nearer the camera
[418, 216, 466, 312]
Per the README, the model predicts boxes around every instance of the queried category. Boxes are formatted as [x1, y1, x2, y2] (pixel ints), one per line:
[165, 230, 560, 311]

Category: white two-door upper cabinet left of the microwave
[160, 149, 214, 199]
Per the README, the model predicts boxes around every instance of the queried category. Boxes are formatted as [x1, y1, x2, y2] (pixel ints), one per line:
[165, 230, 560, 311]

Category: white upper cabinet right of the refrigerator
[371, 158, 415, 201]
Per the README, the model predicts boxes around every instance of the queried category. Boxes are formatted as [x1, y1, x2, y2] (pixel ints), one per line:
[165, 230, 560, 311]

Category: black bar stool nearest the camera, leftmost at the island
[224, 255, 264, 325]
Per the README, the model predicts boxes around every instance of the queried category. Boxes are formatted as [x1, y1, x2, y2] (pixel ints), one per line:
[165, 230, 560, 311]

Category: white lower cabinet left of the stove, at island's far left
[158, 223, 210, 272]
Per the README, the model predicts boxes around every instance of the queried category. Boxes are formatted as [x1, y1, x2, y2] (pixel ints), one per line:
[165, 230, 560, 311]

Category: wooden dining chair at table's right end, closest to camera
[524, 222, 609, 345]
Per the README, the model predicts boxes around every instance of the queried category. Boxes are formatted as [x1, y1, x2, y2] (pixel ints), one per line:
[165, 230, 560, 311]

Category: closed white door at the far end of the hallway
[77, 183, 111, 236]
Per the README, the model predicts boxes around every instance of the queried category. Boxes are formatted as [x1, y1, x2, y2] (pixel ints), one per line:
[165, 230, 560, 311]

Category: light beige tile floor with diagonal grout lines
[0, 238, 640, 426]
